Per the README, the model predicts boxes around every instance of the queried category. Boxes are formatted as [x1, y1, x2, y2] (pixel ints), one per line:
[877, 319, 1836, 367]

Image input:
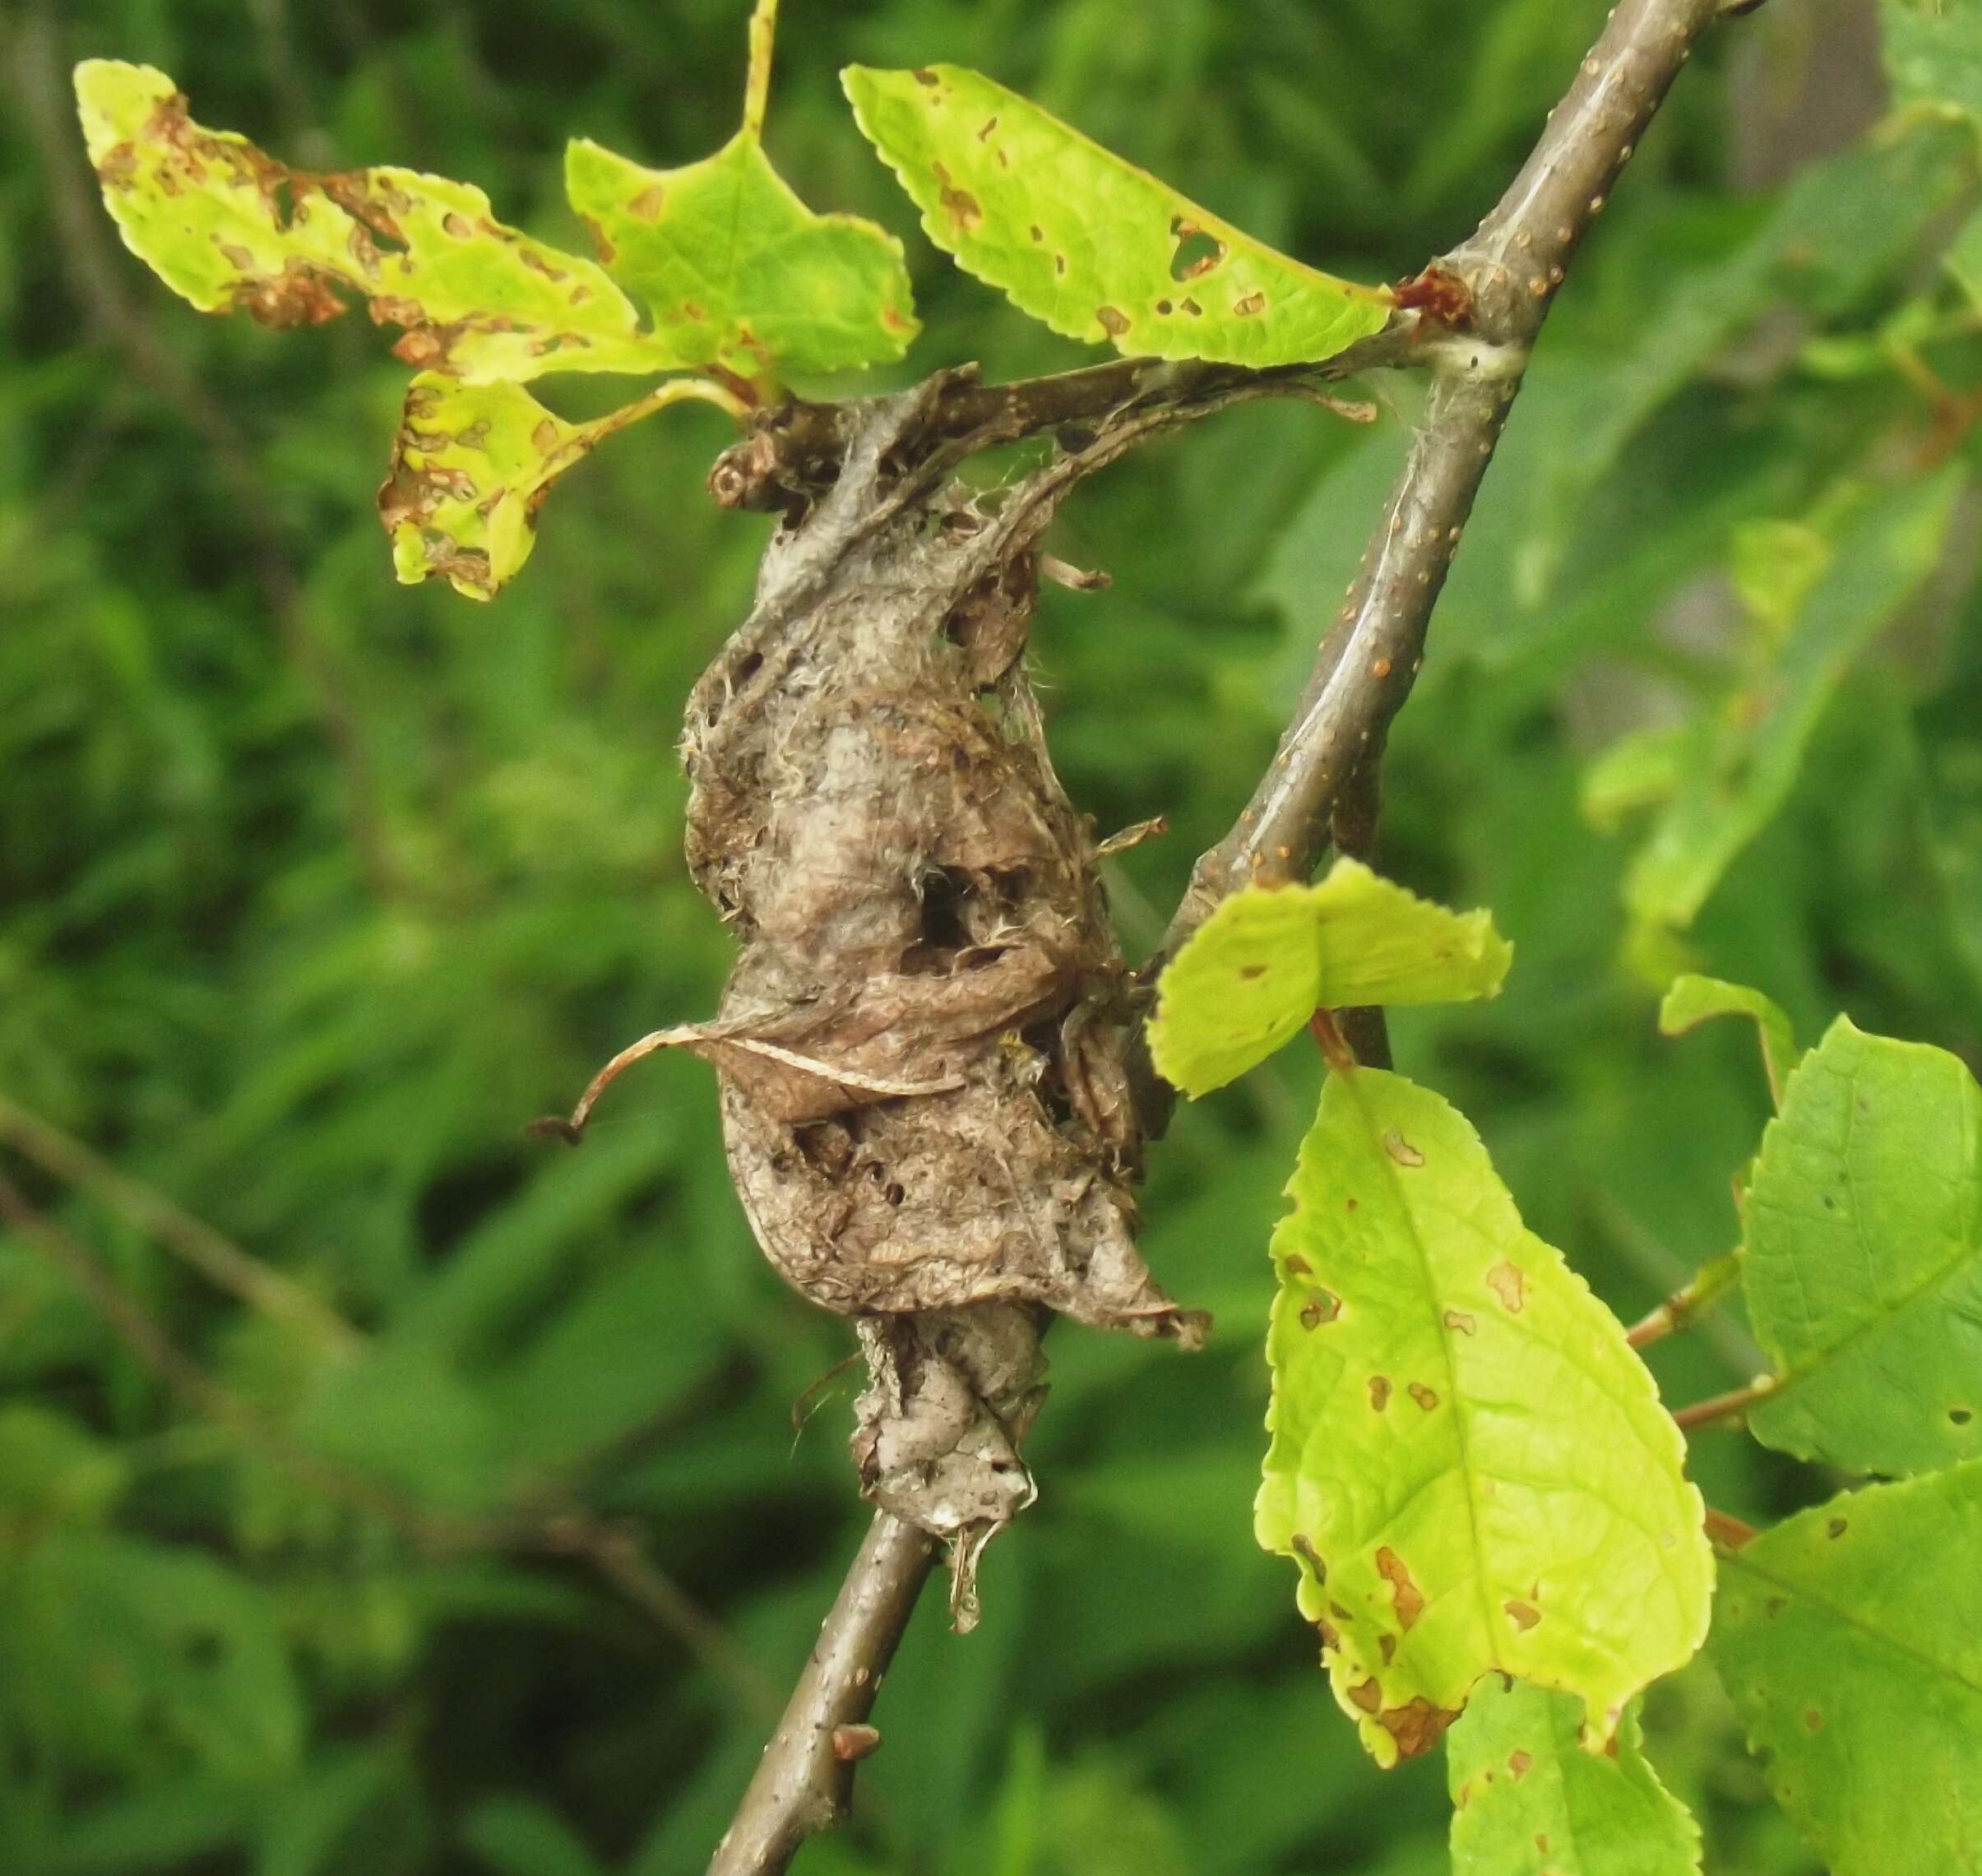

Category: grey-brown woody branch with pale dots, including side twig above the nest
[710, 0, 1746, 1876]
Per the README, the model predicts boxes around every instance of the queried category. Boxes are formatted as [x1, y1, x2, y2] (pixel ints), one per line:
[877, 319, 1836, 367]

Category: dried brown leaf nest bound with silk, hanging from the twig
[547, 387, 1205, 1620]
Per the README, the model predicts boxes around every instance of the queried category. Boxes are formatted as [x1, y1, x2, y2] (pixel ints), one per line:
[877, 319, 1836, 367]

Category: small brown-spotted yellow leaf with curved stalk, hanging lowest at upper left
[378, 371, 741, 599]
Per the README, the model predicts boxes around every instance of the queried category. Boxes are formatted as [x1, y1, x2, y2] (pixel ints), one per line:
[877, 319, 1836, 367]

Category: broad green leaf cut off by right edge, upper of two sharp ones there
[1742, 1017, 1982, 1474]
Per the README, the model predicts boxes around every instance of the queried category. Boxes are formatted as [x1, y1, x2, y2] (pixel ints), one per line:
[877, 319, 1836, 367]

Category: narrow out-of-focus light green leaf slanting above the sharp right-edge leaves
[1625, 468, 1962, 926]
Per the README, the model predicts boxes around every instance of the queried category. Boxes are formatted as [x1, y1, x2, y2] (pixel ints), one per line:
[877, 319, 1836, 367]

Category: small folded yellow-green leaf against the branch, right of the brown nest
[1150, 859, 1514, 1095]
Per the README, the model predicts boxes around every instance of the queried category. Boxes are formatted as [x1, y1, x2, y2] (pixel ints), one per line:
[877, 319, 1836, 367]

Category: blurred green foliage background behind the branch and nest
[0, 0, 1982, 1876]
